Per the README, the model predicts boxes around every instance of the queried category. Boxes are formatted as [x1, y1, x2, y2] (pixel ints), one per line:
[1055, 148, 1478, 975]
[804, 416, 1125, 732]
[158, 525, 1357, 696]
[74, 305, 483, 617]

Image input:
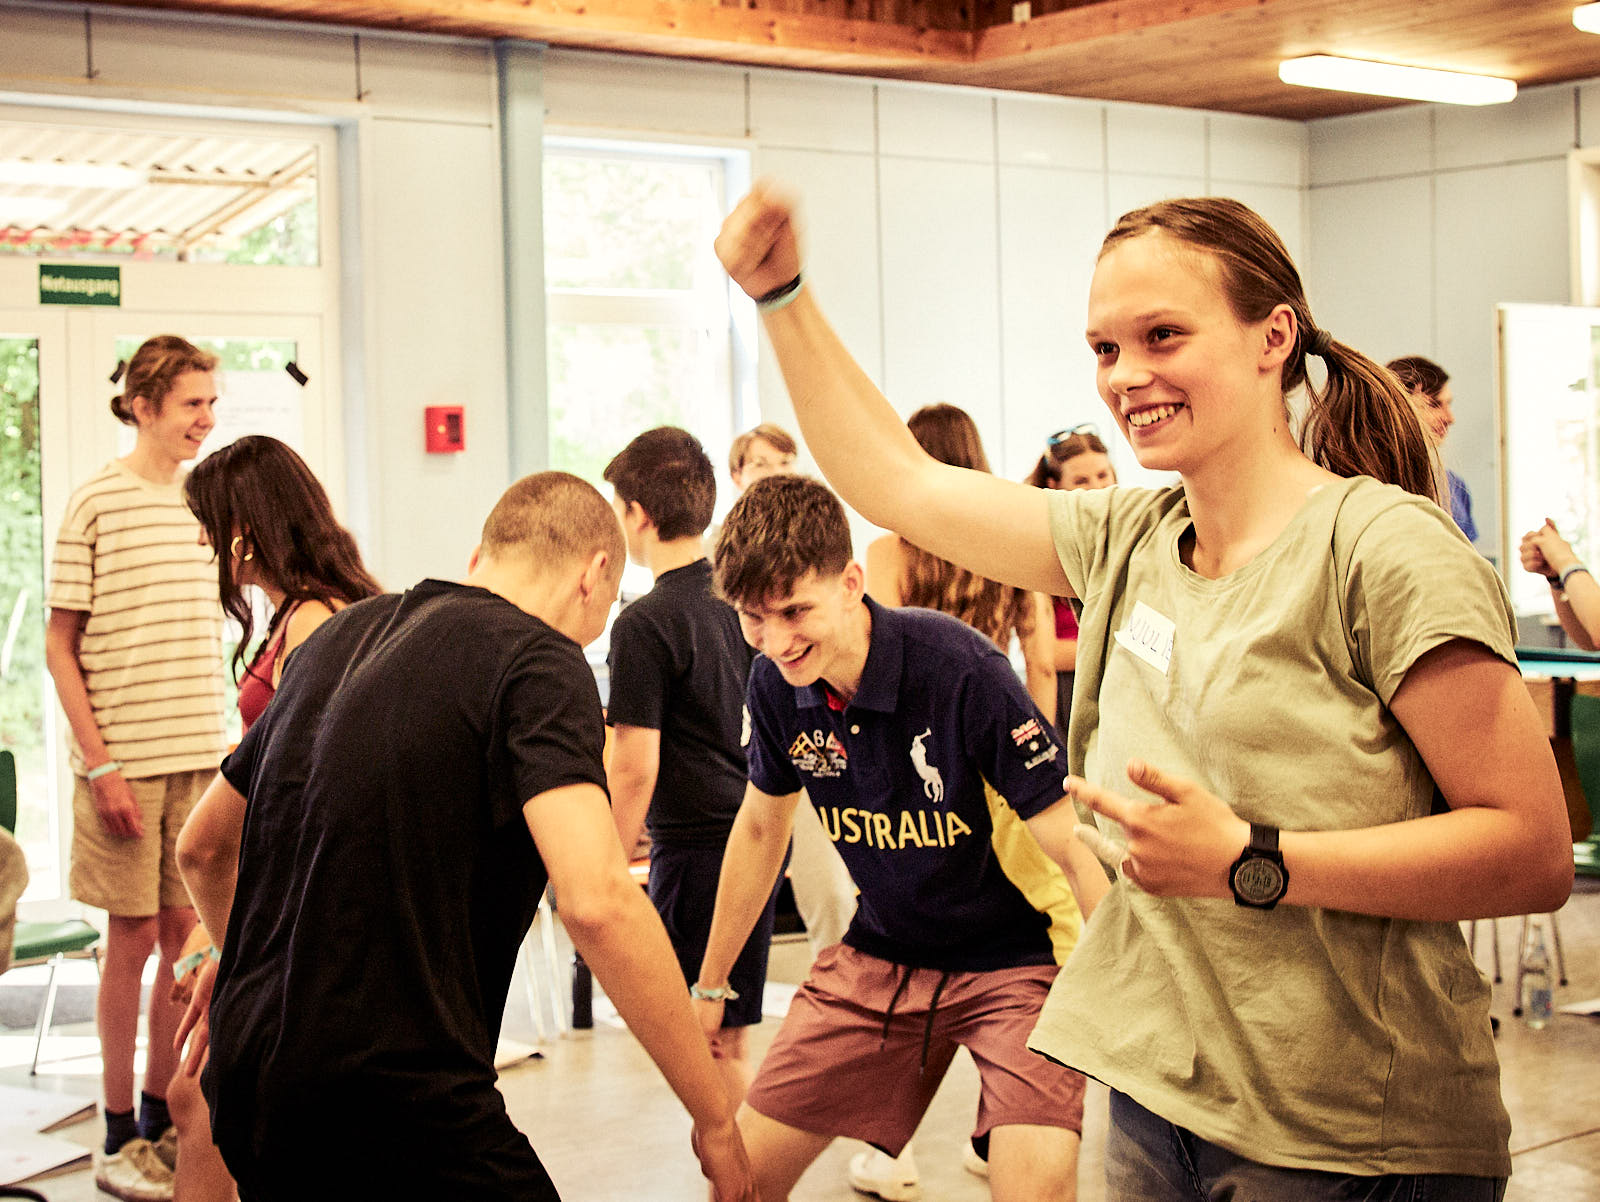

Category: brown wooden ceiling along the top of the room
[37, 0, 1600, 120]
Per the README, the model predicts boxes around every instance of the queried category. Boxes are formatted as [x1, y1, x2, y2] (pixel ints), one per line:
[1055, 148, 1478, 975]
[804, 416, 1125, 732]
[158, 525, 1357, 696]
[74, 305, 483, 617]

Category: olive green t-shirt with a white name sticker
[1030, 477, 1515, 1176]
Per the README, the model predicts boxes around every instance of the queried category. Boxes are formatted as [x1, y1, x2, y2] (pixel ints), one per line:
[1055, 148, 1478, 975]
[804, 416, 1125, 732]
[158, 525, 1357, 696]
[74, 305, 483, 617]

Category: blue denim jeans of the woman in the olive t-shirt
[1106, 1090, 1506, 1202]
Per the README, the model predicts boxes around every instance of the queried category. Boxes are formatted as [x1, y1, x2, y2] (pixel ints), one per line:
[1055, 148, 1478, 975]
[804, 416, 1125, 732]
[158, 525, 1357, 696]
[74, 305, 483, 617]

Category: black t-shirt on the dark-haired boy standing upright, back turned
[606, 559, 755, 847]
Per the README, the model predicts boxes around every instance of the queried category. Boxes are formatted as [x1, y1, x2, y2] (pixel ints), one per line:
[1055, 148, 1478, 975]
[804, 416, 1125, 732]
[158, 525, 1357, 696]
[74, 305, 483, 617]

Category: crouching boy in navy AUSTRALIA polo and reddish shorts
[691, 475, 1106, 1202]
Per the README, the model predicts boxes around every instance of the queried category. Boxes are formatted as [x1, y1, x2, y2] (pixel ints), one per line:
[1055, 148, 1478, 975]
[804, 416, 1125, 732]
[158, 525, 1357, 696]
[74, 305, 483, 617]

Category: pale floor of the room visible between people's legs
[0, 882, 1600, 1202]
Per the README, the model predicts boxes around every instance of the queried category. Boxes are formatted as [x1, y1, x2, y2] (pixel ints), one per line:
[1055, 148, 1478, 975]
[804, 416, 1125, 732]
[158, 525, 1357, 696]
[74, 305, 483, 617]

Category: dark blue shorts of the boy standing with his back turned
[650, 843, 789, 1028]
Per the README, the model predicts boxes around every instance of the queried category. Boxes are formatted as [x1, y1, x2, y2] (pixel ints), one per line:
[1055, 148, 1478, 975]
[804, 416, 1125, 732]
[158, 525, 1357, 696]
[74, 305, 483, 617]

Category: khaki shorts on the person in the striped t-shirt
[69, 770, 216, 919]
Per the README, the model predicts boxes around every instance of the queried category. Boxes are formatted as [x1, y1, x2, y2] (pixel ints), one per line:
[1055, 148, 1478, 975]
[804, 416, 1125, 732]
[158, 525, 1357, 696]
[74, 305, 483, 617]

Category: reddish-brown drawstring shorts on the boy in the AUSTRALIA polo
[746, 943, 1083, 1156]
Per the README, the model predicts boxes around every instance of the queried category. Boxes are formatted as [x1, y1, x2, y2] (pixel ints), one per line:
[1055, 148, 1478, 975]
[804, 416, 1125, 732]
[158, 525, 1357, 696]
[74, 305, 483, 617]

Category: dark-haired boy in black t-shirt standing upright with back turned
[605, 426, 776, 1096]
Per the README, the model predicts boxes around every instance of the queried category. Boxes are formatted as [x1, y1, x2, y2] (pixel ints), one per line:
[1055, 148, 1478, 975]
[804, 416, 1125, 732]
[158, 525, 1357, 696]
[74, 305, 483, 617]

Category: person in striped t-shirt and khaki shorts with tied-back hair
[45, 335, 224, 1197]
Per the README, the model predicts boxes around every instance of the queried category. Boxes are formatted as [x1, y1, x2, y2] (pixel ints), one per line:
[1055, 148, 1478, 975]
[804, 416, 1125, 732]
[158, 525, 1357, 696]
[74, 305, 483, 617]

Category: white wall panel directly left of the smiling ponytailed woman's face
[984, 166, 1114, 479]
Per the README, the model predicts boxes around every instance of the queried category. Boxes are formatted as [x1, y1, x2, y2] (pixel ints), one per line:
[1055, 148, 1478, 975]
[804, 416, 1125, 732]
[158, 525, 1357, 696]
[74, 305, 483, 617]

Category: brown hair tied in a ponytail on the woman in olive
[1101, 197, 1438, 504]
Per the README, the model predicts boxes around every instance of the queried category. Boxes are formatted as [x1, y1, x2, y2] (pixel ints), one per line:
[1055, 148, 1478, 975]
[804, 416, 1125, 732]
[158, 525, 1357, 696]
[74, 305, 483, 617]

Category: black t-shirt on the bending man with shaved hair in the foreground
[205, 581, 605, 1159]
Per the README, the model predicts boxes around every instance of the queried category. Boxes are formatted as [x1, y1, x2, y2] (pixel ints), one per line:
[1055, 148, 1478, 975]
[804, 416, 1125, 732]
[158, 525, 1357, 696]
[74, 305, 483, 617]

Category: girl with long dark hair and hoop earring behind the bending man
[168, 434, 382, 1202]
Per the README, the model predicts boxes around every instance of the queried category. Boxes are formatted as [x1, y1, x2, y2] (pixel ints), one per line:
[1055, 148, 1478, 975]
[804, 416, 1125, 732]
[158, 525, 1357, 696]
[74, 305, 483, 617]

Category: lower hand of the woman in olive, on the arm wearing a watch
[1067, 760, 1250, 898]
